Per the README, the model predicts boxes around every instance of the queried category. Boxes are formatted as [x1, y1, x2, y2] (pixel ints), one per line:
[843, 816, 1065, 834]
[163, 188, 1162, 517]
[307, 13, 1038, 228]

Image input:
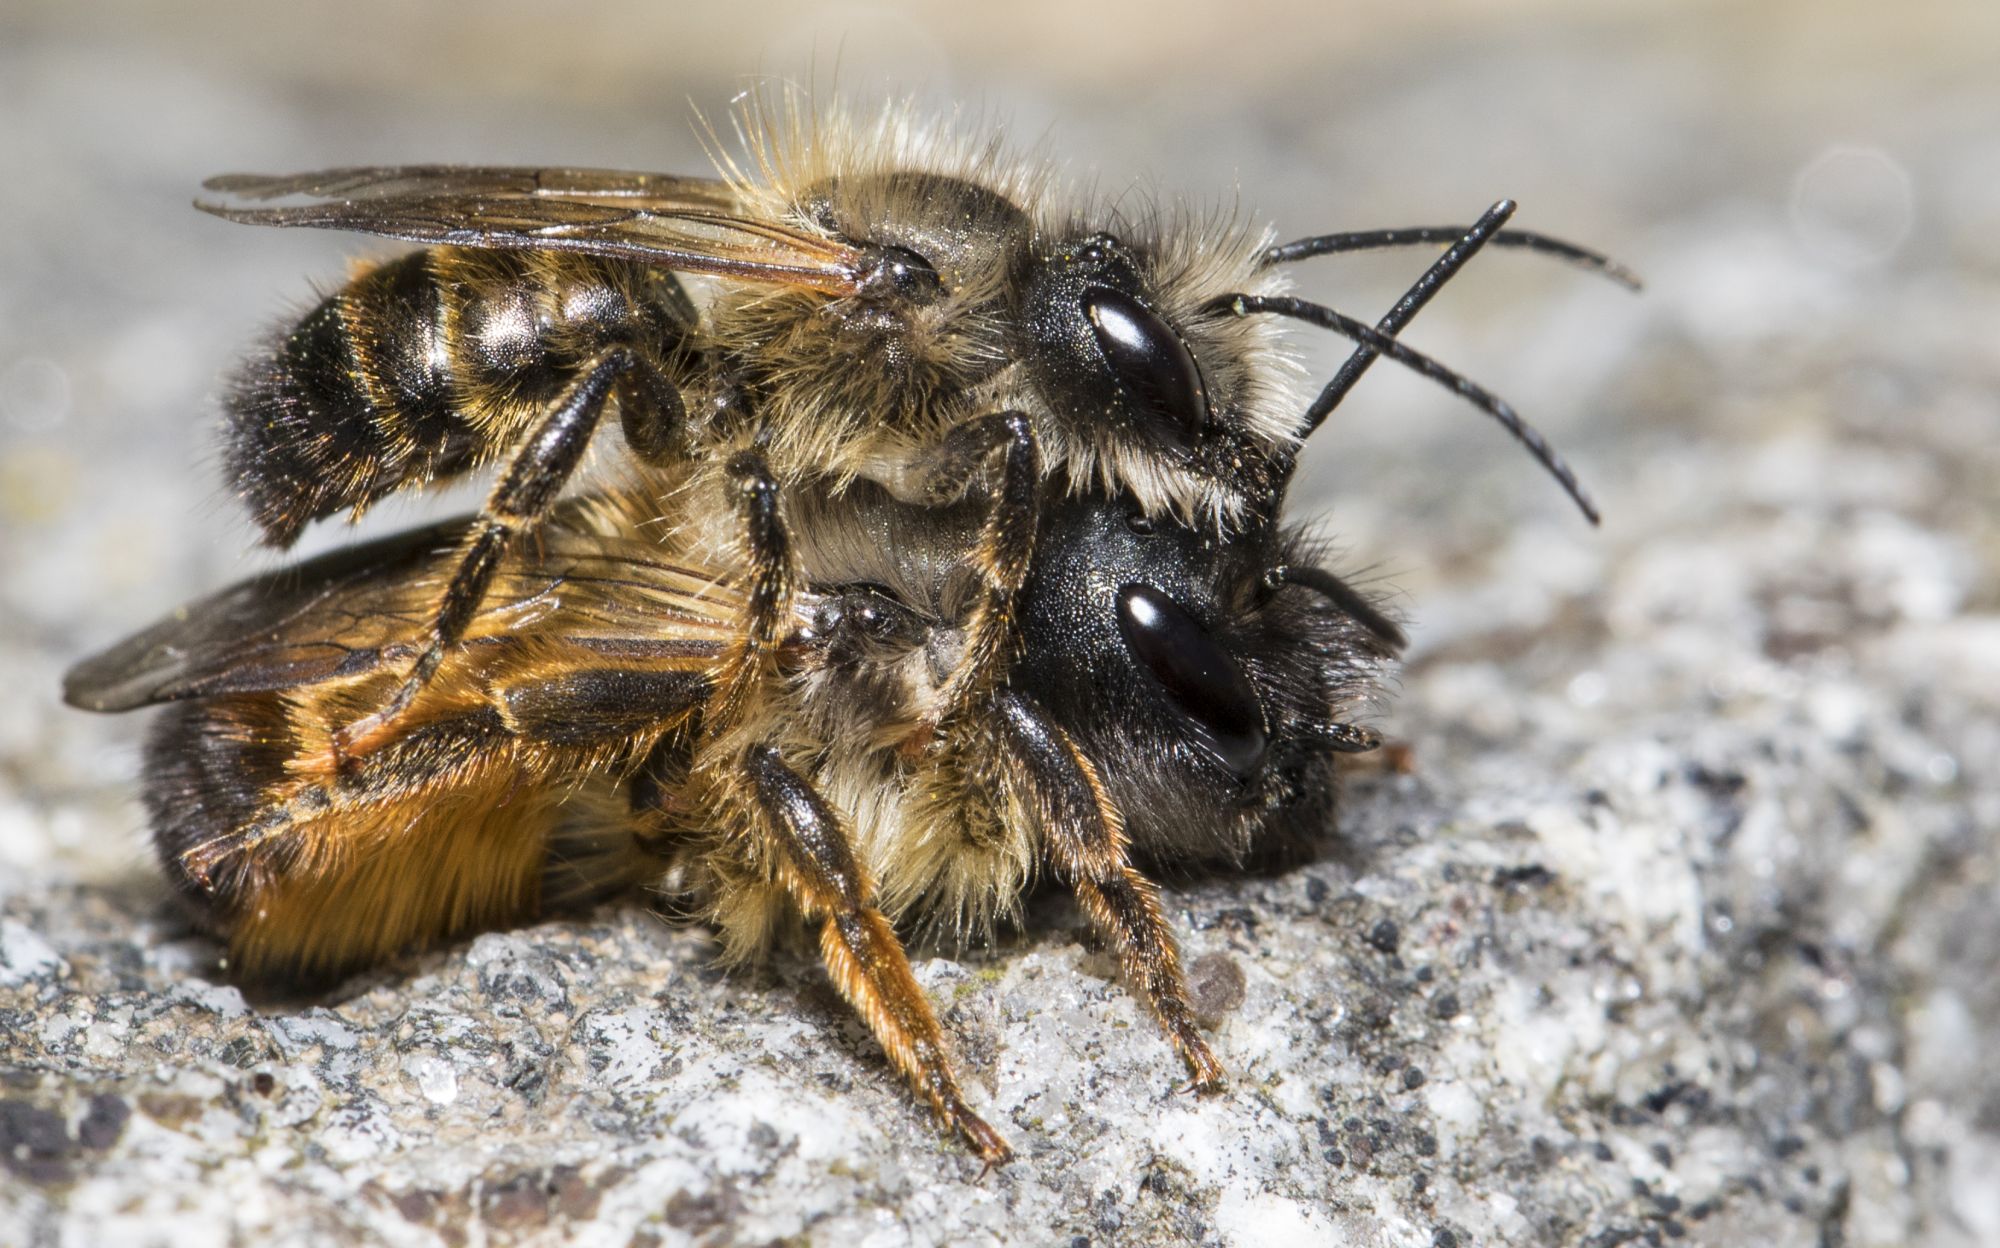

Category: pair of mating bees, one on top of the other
[66, 102, 1622, 1164]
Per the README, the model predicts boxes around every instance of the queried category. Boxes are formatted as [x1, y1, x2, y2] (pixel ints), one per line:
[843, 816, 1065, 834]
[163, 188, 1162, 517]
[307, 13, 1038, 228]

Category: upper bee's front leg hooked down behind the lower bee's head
[918, 412, 1042, 722]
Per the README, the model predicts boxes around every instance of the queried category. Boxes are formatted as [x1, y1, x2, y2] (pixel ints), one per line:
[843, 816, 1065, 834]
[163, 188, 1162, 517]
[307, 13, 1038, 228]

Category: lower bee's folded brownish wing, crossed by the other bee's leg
[62, 520, 742, 710]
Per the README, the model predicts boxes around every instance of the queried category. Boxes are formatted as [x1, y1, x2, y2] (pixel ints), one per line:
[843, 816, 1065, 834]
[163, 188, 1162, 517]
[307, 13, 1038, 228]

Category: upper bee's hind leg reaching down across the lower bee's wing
[334, 346, 680, 760]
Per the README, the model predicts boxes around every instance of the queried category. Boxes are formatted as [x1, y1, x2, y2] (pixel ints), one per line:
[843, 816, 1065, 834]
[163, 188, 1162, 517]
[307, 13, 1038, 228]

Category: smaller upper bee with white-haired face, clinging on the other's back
[198, 100, 1630, 756]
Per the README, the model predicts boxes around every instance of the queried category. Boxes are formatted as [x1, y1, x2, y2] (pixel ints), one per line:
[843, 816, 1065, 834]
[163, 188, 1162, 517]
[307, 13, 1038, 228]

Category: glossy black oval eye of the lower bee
[1118, 582, 1264, 776]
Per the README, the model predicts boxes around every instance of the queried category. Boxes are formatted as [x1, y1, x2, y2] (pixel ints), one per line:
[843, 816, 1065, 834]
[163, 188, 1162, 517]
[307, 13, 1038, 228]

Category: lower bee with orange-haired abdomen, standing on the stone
[66, 460, 1396, 1164]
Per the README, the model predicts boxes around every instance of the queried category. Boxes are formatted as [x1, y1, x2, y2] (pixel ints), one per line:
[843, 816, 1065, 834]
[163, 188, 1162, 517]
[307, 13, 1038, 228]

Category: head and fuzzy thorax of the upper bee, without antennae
[716, 170, 1298, 528]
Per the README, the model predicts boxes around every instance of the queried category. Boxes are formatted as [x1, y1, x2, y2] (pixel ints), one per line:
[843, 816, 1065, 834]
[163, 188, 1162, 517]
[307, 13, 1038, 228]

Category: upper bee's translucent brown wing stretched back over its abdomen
[194, 164, 862, 294]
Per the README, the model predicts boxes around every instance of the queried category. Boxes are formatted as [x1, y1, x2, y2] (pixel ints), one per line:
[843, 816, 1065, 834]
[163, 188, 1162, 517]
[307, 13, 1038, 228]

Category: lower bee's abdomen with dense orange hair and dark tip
[146, 694, 656, 988]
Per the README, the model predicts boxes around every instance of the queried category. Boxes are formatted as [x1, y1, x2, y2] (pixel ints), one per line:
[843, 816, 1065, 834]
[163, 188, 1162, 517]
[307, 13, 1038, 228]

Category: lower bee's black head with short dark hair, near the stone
[1008, 496, 1402, 860]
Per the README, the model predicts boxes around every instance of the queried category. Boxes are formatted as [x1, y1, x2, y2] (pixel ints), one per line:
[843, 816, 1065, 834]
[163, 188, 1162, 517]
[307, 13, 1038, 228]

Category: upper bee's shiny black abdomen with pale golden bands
[224, 248, 694, 548]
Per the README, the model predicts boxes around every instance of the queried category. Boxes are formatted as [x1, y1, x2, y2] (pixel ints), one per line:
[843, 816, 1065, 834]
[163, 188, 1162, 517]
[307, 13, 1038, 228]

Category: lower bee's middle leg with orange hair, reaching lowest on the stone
[738, 746, 1014, 1166]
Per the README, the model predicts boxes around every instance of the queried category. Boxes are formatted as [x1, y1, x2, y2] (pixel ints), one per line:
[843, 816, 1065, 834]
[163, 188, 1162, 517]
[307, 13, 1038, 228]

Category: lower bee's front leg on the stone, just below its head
[994, 690, 1222, 1092]
